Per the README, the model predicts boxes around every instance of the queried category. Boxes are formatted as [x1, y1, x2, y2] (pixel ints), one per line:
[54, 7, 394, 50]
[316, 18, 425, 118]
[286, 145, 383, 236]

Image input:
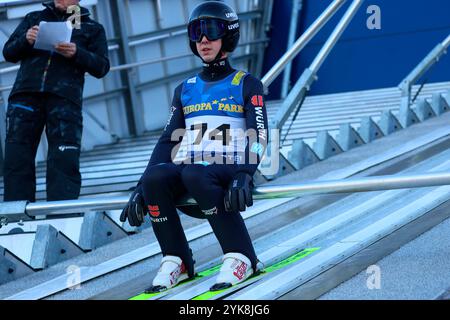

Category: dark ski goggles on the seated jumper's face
[188, 19, 227, 42]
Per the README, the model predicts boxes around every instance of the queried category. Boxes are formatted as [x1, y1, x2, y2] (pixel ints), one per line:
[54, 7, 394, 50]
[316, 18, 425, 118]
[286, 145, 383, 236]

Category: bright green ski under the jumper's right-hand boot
[192, 248, 320, 300]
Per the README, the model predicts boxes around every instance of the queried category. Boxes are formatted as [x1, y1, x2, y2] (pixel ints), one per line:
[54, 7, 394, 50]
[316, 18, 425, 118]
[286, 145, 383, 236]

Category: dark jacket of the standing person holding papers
[3, 3, 110, 105]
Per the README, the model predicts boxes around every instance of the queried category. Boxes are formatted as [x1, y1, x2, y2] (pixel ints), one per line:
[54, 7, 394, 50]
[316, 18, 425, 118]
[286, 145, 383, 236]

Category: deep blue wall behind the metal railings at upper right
[264, 0, 450, 99]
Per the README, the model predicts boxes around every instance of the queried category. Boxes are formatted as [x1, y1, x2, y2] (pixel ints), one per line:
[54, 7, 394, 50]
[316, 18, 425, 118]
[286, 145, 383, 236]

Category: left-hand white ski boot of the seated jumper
[146, 256, 189, 293]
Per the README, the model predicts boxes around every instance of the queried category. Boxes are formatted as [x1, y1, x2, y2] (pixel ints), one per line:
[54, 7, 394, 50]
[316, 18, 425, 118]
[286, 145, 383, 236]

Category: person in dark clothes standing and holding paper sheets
[3, 0, 110, 201]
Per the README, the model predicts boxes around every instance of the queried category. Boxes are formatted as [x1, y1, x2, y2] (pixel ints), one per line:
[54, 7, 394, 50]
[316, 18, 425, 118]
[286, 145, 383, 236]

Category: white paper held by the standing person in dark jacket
[34, 21, 72, 51]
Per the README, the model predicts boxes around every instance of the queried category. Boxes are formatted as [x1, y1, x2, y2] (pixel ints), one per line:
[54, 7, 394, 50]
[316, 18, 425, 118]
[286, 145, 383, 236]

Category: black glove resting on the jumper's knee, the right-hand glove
[225, 172, 254, 212]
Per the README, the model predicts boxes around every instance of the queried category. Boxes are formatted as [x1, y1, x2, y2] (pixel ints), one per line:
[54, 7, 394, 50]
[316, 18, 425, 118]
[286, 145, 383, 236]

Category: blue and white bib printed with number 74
[181, 71, 247, 158]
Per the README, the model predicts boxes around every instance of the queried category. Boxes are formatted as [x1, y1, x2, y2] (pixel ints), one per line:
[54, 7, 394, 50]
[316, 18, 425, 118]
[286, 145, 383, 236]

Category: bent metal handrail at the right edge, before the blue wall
[398, 35, 450, 118]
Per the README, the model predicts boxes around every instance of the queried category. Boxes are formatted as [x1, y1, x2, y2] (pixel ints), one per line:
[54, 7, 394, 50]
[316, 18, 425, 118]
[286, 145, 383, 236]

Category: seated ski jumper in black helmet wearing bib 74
[121, 1, 267, 292]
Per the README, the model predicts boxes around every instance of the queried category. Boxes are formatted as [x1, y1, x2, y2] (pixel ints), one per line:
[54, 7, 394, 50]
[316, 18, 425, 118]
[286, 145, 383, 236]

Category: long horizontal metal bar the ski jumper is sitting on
[0, 172, 450, 222]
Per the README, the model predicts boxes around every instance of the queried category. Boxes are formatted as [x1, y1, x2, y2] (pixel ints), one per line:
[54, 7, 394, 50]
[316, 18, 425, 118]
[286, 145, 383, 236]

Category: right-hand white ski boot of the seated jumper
[210, 252, 253, 291]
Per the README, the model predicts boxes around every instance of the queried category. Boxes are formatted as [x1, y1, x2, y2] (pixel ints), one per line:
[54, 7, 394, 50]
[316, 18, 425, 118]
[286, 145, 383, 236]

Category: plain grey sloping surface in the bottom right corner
[319, 215, 450, 300]
